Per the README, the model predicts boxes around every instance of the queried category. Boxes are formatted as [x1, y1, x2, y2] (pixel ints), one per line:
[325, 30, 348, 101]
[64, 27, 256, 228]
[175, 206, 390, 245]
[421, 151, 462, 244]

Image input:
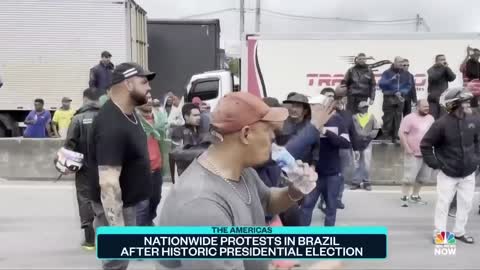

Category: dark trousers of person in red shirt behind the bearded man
[136, 170, 163, 226]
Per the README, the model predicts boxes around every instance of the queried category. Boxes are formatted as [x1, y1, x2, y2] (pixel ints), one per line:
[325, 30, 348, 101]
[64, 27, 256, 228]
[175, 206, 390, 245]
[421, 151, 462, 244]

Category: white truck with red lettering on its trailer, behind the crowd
[187, 33, 480, 125]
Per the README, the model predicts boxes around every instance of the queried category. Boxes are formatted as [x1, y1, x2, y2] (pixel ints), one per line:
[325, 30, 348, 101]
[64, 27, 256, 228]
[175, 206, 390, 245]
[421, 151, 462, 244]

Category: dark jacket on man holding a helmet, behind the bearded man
[65, 102, 100, 170]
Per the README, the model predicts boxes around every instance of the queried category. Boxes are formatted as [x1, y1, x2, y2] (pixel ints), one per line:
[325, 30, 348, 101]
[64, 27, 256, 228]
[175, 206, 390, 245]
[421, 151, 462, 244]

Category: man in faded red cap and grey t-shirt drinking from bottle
[160, 92, 328, 270]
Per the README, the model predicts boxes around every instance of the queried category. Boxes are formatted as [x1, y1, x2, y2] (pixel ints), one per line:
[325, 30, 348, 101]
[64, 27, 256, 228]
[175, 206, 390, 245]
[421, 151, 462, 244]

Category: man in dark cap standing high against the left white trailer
[88, 51, 114, 96]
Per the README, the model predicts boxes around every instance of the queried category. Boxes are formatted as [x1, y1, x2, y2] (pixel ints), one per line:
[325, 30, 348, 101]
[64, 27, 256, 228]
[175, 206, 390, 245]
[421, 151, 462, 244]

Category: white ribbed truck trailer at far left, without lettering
[0, 0, 148, 137]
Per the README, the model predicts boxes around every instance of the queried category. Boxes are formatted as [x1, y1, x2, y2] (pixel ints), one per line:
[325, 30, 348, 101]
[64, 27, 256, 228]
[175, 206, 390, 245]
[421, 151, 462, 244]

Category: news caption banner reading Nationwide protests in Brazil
[97, 227, 387, 260]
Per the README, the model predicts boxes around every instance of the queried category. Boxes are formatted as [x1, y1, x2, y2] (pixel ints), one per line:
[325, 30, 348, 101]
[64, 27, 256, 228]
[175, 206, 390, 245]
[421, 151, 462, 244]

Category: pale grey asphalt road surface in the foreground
[0, 181, 480, 270]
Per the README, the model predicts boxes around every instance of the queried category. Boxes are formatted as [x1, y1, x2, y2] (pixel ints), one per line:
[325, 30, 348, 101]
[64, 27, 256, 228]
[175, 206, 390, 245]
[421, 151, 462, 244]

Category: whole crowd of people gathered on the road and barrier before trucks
[44, 48, 480, 269]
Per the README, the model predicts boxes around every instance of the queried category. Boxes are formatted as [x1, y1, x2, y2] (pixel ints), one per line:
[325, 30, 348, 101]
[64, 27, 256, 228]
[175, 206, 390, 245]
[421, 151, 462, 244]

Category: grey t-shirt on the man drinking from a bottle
[159, 160, 270, 270]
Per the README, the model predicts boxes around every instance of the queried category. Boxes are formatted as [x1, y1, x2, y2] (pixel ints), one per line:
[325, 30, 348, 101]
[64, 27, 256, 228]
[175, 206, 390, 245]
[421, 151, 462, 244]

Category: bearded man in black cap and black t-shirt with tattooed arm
[92, 63, 155, 269]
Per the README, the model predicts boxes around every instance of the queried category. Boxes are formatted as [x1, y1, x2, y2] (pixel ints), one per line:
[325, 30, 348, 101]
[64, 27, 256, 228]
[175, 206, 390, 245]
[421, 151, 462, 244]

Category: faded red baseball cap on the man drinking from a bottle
[211, 92, 288, 134]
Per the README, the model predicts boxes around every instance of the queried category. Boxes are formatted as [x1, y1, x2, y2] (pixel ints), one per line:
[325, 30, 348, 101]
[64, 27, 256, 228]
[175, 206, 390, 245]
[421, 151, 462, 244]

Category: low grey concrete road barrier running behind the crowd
[0, 138, 478, 185]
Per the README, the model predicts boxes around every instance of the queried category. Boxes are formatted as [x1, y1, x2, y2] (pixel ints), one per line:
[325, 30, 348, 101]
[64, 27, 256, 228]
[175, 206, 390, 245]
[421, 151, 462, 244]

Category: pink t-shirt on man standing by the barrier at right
[398, 112, 435, 157]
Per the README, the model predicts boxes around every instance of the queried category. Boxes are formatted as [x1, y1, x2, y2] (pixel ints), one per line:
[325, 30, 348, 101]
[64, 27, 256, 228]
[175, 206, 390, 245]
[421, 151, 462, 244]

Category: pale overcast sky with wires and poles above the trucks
[136, 0, 480, 54]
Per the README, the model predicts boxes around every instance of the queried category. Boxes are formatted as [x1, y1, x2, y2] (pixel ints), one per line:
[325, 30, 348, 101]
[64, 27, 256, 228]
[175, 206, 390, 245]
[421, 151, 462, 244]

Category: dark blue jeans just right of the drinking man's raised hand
[302, 173, 343, 226]
